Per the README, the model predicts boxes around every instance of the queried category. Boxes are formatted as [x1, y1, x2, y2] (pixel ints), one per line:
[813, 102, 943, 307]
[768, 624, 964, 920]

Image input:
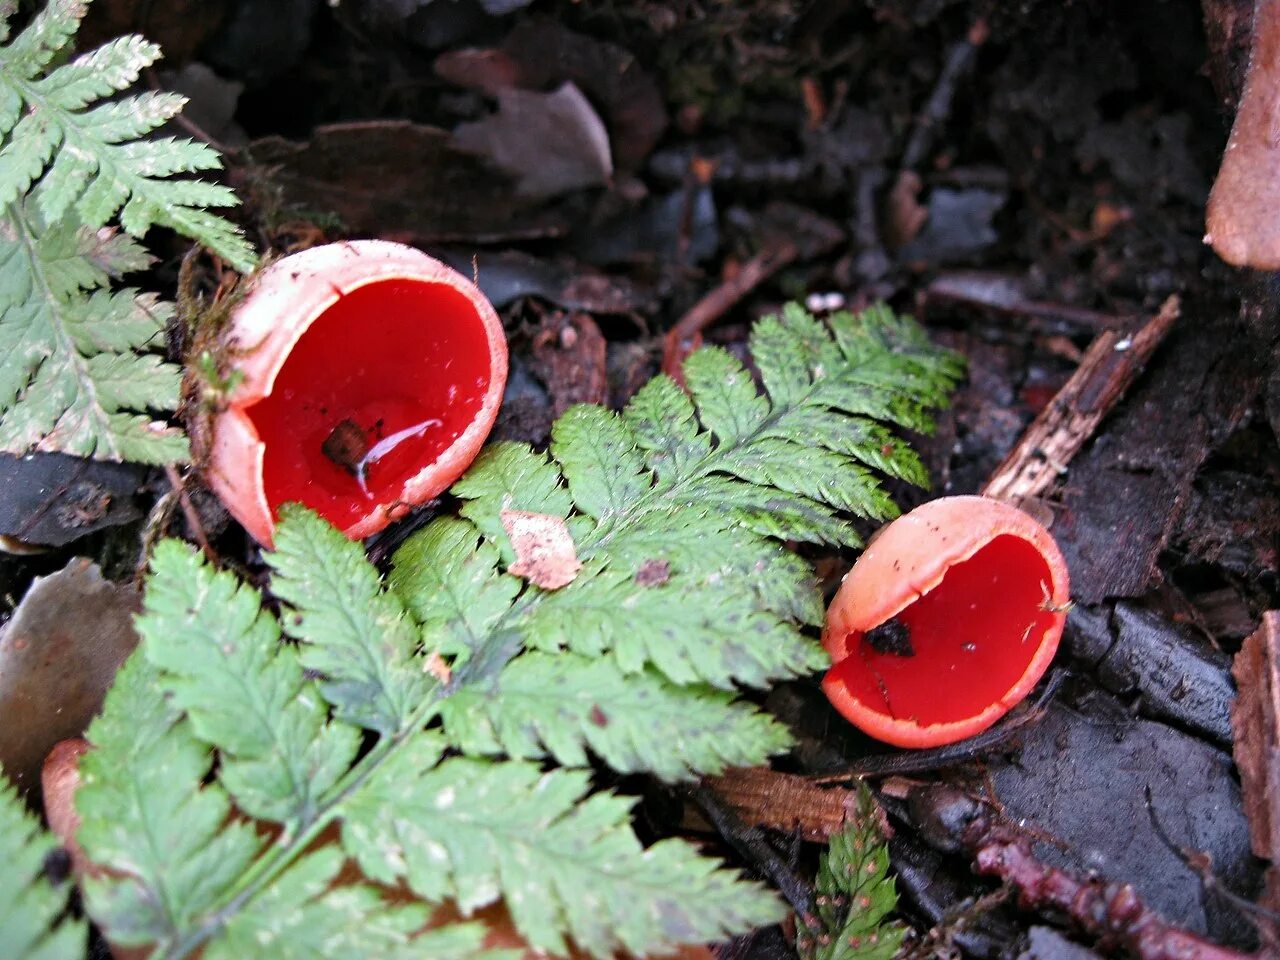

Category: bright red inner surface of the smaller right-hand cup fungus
[828, 535, 1055, 726]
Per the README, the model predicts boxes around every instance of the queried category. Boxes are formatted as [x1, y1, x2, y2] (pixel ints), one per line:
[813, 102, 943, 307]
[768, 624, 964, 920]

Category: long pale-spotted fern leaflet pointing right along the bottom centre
[343, 739, 782, 957]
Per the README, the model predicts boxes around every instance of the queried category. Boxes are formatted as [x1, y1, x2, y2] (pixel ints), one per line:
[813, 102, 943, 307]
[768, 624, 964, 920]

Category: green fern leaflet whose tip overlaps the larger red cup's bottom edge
[266, 504, 434, 733]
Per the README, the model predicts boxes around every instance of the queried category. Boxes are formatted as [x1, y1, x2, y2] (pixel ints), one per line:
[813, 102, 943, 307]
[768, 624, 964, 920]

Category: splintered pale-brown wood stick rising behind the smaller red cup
[983, 296, 1180, 504]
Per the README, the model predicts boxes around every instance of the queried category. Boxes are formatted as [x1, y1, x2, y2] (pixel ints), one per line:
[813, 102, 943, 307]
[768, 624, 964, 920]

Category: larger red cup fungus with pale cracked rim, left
[206, 241, 507, 547]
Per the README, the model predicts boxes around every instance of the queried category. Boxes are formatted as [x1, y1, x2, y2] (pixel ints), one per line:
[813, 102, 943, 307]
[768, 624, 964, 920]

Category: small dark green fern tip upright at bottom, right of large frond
[796, 785, 906, 960]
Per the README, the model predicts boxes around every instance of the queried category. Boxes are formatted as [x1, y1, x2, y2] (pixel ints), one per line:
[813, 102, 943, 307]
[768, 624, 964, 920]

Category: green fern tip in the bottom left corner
[0, 771, 88, 960]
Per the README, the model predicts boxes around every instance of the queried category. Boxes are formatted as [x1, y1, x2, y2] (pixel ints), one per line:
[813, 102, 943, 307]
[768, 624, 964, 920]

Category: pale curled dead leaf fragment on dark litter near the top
[453, 83, 613, 197]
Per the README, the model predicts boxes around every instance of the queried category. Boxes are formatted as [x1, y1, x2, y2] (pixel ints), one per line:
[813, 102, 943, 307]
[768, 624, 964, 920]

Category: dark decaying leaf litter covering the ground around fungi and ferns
[0, 0, 1280, 956]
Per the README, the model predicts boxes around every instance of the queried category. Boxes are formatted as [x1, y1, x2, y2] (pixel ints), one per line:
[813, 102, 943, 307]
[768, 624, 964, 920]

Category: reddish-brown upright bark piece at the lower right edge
[1231, 611, 1280, 954]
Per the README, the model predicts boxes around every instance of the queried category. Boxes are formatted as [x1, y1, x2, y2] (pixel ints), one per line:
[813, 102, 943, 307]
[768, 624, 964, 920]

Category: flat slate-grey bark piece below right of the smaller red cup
[988, 694, 1261, 947]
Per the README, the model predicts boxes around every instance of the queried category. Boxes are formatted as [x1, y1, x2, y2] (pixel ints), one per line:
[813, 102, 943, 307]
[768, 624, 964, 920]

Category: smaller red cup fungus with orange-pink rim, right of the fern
[822, 497, 1070, 748]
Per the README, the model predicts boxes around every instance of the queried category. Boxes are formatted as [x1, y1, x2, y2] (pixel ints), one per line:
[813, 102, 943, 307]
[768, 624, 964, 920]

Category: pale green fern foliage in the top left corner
[0, 0, 255, 463]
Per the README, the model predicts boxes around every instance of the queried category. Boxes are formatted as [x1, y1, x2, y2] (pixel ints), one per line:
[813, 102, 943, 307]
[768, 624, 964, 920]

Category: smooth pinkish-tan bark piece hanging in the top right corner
[1204, 0, 1280, 270]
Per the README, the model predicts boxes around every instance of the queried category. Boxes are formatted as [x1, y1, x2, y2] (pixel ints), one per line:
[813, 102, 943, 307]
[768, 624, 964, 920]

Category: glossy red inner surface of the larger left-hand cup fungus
[248, 279, 490, 527]
